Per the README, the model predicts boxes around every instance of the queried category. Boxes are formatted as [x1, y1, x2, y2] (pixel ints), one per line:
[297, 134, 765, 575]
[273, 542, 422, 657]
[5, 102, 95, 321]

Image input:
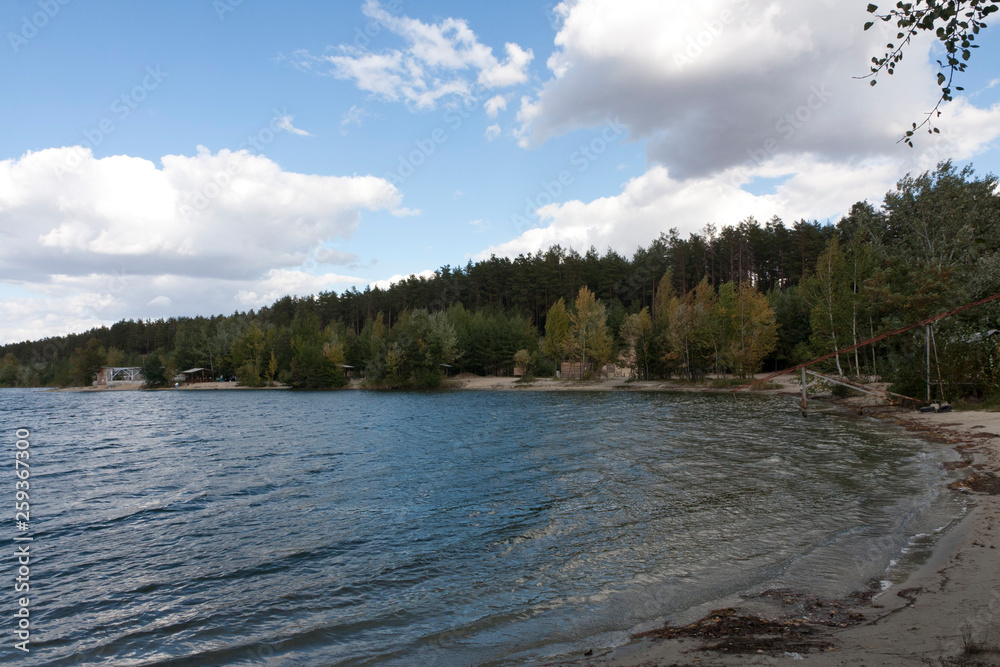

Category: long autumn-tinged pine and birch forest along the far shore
[0, 162, 1000, 398]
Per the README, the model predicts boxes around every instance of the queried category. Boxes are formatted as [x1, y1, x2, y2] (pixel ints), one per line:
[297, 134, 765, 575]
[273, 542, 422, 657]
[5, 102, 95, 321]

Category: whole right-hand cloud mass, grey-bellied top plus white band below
[478, 0, 1000, 258]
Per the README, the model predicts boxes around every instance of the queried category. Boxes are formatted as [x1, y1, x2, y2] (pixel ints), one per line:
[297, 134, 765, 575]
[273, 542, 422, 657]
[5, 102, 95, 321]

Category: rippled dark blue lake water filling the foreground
[0, 390, 962, 666]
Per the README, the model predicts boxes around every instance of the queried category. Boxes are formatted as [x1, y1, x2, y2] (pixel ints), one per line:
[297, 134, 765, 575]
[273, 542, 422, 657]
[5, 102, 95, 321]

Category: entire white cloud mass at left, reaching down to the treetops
[0, 146, 402, 341]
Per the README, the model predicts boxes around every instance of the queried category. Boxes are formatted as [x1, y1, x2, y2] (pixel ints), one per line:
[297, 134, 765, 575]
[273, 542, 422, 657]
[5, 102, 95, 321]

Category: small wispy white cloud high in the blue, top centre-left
[291, 0, 534, 109]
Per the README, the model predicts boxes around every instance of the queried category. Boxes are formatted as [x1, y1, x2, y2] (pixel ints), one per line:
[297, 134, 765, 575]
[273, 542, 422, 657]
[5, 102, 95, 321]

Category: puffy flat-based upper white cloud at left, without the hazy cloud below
[0, 147, 401, 280]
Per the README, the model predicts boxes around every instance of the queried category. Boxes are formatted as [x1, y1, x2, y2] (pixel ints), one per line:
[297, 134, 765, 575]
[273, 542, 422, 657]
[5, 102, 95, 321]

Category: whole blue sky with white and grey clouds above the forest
[0, 0, 1000, 343]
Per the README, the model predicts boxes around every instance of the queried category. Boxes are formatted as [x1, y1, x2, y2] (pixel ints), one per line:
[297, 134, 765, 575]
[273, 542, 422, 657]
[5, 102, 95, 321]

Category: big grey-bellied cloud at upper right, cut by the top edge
[518, 0, 984, 178]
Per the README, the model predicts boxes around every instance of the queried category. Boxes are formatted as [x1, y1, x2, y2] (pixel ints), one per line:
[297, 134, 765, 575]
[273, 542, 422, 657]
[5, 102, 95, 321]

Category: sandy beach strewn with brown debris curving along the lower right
[535, 396, 1000, 667]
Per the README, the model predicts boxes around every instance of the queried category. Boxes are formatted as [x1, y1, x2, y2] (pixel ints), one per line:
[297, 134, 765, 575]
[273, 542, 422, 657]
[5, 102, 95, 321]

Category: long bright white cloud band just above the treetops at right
[484, 99, 1000, 259]
